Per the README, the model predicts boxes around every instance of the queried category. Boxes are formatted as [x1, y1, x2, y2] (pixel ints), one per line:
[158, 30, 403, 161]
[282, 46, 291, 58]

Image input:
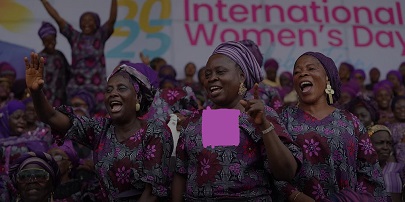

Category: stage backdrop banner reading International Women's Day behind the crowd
[0, 0, 405, 79]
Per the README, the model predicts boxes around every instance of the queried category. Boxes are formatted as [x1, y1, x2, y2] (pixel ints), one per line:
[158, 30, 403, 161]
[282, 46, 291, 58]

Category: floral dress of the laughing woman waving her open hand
[55, 106, 173, 201]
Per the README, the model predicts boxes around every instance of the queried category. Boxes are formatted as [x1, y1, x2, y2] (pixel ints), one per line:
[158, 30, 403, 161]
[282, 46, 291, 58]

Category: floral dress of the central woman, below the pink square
[176, 107, 302, 201]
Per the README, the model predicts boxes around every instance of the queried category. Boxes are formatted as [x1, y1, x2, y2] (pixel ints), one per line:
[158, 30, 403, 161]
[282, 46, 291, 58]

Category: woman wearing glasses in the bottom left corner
[9, 152, 60, 202]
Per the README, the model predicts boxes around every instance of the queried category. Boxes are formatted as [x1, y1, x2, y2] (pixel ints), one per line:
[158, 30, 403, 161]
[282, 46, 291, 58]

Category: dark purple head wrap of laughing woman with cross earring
[294, 52, 342, 102]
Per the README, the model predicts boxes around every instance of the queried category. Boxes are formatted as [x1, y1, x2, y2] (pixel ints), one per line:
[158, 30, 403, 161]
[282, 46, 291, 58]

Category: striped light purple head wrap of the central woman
[212, 41, 263, 90]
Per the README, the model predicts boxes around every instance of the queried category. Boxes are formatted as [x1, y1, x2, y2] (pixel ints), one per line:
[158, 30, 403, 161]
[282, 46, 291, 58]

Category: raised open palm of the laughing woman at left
[24, 53, 45, 92]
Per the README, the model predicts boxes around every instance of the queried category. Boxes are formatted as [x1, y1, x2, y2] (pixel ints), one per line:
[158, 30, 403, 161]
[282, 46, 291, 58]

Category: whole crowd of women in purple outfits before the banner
[0, 0, 405, 202]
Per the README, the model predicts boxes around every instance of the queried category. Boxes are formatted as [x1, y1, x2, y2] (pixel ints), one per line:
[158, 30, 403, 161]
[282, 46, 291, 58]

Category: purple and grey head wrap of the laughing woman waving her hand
[107, 63, 159, 115]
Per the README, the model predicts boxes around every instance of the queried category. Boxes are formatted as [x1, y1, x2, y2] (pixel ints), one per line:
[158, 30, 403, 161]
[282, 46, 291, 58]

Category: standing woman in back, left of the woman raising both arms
[38, 22, 70, 107]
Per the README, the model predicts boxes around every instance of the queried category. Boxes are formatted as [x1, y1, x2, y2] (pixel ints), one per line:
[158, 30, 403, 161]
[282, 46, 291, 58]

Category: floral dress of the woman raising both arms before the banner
[60, 24, 114, 111]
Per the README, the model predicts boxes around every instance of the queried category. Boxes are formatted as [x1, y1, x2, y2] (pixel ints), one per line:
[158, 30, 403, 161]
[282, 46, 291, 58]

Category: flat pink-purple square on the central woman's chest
[202, 107, 240, 148]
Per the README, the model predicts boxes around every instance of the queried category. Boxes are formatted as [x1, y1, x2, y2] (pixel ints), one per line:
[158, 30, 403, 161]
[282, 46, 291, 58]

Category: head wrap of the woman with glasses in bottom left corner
[9, 152, 60, 187]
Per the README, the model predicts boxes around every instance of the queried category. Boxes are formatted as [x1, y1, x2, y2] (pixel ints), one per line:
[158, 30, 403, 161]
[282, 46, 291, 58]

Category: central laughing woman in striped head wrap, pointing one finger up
[172, 41, 302, 201]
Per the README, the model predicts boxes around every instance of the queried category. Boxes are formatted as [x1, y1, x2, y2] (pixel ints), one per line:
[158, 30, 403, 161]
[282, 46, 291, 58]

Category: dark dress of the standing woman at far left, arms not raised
[39, 50, 70, 107]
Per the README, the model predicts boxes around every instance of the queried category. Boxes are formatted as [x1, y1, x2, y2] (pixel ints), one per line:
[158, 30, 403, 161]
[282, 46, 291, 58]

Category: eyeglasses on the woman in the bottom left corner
[17, 168, 49, 183]
